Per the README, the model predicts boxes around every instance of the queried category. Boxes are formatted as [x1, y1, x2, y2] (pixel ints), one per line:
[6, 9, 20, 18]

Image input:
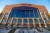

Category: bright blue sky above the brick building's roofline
[0, 0, 50, 13]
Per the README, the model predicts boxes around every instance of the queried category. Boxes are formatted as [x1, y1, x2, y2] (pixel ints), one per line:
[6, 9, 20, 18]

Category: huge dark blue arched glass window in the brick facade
[10, 6, 40, 18]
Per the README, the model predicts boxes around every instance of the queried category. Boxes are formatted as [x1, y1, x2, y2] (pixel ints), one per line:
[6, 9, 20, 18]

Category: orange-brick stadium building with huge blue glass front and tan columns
[0, 3, 50, 33]
